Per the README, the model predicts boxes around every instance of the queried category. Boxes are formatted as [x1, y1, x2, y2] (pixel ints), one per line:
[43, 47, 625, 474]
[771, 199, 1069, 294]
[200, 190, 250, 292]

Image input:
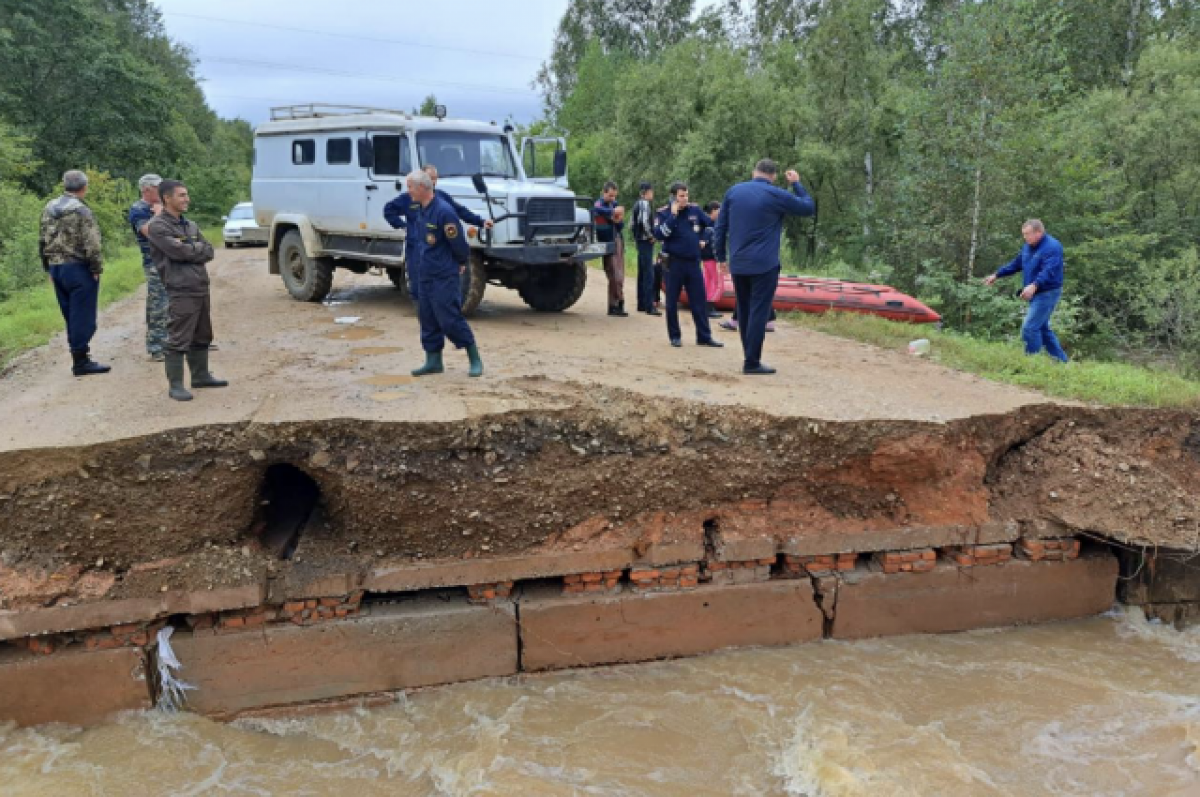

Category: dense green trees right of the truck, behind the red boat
[538, 0, 1200, 370]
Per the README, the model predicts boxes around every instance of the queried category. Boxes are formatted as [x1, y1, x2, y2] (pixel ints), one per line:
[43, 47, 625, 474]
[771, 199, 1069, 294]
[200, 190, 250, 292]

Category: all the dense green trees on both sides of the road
[0, 0, 1200, 372]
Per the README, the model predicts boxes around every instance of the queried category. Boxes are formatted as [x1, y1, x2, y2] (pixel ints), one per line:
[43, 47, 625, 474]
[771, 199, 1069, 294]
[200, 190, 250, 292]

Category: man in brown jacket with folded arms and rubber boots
[145, 180, 229, 401]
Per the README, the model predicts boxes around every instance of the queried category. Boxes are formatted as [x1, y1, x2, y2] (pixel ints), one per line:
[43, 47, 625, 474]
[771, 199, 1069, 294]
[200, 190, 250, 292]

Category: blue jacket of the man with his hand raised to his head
[713, 178, 816, 276]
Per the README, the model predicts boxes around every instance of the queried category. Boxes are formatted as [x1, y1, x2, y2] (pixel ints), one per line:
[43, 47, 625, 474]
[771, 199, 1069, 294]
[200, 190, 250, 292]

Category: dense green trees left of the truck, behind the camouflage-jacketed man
[0, 0, 253, 300]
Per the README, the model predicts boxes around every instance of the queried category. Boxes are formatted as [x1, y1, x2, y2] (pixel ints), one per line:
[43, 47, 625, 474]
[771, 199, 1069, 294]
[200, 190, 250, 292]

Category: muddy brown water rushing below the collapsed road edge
[0, 612, 1200, 797]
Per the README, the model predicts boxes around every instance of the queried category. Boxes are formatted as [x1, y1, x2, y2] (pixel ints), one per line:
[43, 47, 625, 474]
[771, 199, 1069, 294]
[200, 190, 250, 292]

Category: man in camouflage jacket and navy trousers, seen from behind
[37, 170, 112, 377]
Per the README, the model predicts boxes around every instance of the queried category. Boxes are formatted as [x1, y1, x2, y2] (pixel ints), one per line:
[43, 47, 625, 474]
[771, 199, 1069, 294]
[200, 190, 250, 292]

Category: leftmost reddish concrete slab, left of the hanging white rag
[0, 648, 151, 726]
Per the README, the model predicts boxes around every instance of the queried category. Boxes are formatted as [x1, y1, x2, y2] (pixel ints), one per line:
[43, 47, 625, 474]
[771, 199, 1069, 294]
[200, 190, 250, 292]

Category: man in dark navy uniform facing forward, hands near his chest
[654, 182, 725, 348]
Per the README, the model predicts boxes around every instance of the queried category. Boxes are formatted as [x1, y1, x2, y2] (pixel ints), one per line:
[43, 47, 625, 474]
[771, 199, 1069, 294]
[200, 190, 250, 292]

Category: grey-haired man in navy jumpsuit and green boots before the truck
[408, 166, 484, 377]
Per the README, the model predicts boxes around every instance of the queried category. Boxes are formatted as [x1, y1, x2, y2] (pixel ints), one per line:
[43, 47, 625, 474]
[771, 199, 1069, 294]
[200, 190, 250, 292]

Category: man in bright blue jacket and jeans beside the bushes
[983, 218, 1067, 362]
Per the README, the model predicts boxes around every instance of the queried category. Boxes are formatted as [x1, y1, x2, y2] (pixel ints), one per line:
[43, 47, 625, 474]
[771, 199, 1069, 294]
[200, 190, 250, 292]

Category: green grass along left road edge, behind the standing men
[0, 227, 224, 370]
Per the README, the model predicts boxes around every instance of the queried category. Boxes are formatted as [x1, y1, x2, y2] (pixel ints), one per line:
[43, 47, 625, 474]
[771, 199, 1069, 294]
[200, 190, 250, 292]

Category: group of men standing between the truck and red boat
[593, 158, 816, 374]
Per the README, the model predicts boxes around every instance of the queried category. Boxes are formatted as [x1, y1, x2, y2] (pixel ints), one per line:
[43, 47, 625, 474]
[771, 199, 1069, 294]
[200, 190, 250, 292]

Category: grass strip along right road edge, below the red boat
[784, 312, 1200, 409]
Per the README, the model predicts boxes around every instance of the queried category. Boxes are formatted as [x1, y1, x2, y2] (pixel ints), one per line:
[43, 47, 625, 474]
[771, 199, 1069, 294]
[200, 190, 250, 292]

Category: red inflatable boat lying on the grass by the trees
[700, 275, 942, 324]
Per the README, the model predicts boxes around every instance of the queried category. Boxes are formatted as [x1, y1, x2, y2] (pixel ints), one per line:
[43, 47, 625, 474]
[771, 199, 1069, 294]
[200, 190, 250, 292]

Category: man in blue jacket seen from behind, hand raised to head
[710, 158, 816, 374]
